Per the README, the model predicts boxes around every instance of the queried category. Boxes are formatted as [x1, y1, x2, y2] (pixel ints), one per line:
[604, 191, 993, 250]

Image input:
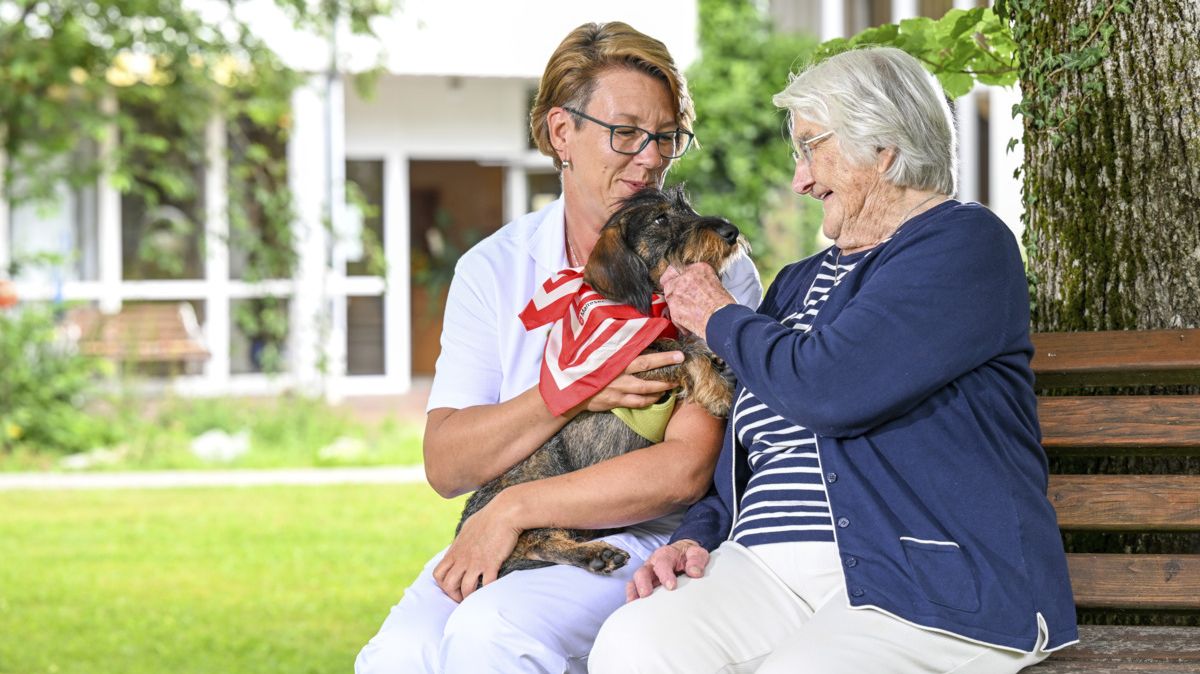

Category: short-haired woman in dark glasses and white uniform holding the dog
[355, 22, 762, 674]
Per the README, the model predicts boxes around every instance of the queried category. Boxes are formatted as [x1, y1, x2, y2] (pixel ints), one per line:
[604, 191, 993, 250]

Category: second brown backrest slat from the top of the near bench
[1038, 396, 1200, 455]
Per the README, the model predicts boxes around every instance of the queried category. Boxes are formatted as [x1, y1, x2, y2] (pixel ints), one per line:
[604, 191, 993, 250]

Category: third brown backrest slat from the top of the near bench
[1048, 475, 1200, 531]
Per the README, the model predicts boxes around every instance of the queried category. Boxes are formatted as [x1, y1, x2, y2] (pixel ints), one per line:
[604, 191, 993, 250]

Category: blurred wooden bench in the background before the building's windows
[66, 302, 210, 374]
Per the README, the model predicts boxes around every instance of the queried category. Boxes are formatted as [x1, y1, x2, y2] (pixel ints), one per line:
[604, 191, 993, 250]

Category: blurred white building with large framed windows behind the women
[0, 0, 1020, 398]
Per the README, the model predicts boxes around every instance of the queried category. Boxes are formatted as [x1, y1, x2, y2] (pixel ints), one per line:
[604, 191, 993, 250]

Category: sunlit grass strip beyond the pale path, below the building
[0, 396, 424, 471]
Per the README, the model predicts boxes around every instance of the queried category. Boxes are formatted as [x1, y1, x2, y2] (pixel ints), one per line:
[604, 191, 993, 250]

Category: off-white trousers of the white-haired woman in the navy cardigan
[589, 541, 1046, 674]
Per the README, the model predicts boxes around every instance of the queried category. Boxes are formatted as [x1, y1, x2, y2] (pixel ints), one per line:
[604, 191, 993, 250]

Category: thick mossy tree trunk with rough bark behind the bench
[1009, 0, 1200, 331]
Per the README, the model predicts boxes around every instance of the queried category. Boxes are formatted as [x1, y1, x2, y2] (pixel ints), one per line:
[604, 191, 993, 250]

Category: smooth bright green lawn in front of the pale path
[0, 485, 462, 674]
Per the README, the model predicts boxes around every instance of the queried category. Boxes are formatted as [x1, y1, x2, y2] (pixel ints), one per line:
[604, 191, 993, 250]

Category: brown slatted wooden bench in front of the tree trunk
[1027, 330, 1200, 674]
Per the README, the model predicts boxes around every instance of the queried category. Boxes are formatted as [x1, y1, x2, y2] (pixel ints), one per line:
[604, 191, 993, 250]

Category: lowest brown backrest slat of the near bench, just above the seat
[1067, 554, 1200, 609]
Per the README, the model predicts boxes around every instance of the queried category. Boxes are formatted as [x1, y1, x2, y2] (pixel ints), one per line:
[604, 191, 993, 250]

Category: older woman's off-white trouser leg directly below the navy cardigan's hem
[757, 596, 1048, 674]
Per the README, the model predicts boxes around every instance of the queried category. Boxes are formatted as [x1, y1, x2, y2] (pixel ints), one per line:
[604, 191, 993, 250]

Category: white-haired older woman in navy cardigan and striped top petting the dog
[590, 48, 1076, 674]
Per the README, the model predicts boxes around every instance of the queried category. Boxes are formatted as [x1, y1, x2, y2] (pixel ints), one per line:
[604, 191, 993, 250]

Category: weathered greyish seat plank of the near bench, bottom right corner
[1026, 625, 1200, 674]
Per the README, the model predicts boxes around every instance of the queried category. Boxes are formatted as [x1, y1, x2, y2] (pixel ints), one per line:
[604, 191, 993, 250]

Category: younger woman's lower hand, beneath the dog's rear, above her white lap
[433, 497, 521, 602]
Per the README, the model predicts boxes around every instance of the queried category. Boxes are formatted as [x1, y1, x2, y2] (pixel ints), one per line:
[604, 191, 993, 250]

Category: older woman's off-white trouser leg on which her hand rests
[589, 541, 812, 674]
